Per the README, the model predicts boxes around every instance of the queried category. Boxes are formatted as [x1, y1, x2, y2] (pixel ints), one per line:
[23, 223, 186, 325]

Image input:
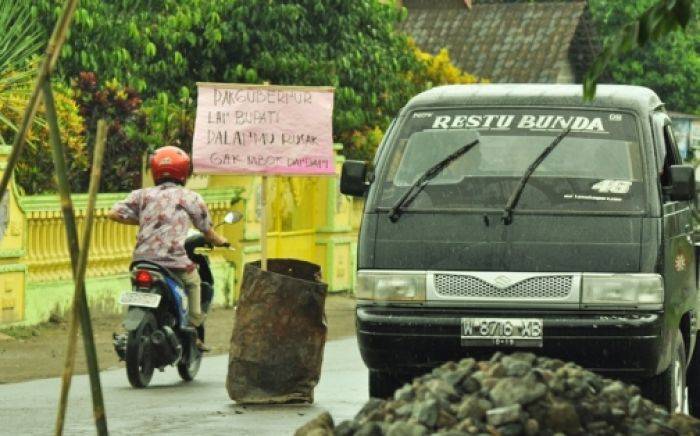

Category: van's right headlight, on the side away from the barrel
[581, 274, 664, 309]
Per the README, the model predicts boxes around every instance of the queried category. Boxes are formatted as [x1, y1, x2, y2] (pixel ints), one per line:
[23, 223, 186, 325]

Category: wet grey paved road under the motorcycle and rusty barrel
[0, 338, 367, 436]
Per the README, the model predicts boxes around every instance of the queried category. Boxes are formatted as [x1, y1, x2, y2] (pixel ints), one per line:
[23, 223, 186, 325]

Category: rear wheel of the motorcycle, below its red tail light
[125, 312, 156, 388]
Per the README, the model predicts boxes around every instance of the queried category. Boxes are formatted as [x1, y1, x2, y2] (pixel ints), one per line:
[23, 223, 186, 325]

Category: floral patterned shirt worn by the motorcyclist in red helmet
[112, 182, 212, 270]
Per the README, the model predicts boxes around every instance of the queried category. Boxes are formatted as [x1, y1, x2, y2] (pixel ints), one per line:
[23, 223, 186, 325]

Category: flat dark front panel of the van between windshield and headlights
[370, 213, 643, 273]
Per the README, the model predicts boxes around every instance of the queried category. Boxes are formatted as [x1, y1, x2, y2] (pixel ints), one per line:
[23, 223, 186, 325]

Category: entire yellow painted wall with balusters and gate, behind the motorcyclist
[0, 147, 362, 325]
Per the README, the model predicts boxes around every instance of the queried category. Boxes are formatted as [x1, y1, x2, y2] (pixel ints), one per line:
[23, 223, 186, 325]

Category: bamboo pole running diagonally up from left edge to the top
[0, 0, 78, 205]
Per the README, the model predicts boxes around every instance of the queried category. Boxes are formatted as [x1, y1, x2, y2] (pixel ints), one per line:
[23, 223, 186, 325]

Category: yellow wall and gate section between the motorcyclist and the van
[207, 147, 362, 298]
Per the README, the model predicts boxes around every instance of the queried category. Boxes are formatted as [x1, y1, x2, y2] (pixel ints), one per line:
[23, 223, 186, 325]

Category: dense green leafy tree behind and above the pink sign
[33, 0, 425, 157]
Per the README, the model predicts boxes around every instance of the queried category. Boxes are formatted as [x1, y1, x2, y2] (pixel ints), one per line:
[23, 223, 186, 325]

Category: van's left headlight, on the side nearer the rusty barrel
[355, 271, 427, 301]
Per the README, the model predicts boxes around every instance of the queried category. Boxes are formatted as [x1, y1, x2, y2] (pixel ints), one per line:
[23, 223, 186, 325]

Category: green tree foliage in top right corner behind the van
[584, 0, 700, 113]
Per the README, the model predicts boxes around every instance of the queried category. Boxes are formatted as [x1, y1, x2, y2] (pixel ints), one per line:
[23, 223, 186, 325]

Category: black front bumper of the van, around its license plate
[356, 305, 671, 379]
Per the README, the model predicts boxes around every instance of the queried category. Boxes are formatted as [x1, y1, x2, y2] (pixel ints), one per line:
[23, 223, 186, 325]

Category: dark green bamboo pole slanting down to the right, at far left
[42, 81, 108, 436]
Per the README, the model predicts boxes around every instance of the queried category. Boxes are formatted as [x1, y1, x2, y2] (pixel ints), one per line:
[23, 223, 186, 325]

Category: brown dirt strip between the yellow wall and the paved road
[0, 295, 355, 383]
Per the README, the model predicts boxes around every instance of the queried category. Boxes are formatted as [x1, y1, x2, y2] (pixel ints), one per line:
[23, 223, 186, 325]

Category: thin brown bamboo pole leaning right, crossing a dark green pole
[55, 120, 107, 436]
